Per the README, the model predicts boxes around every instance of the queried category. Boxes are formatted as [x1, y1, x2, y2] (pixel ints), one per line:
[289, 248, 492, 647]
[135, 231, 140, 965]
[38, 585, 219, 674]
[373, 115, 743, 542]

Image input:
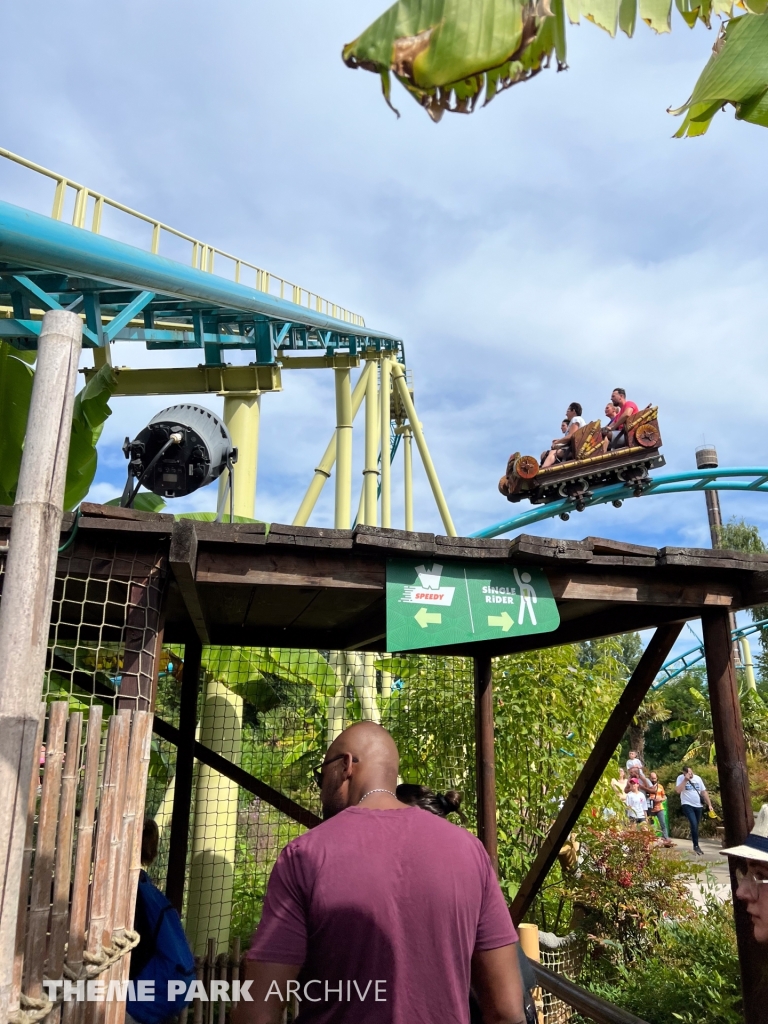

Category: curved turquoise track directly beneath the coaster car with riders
[469, 466, 768, 538]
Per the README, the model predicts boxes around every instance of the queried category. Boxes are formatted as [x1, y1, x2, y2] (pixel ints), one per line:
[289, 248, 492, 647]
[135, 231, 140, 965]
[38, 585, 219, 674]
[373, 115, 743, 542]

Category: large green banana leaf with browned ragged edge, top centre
[342, 0, 565, 121]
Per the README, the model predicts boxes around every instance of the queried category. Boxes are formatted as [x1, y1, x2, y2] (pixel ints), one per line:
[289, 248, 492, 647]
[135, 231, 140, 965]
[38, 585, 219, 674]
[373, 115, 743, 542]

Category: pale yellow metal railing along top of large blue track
[0, 147, 366, 327]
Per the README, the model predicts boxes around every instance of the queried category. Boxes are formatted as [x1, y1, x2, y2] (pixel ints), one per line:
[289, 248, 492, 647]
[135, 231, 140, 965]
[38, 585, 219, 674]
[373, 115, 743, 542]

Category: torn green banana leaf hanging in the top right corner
[670, 14, 768, 138]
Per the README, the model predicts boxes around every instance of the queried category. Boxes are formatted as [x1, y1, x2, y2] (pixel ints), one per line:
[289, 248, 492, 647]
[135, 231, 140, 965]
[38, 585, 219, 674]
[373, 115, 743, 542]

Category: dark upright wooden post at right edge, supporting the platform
[701, 608, 768, 1024]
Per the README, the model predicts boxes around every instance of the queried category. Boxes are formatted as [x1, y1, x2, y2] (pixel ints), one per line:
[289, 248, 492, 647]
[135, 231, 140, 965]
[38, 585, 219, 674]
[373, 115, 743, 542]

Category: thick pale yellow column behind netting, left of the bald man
[185, 677, 243, 955]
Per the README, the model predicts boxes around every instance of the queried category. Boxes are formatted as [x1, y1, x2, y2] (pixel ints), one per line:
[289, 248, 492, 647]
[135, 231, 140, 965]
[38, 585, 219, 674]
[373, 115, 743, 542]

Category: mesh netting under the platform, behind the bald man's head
[146, 647, 474, 954]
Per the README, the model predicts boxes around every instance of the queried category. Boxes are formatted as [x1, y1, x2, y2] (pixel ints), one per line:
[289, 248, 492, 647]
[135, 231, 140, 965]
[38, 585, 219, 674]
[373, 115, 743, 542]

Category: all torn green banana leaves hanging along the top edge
[342, 0, 768, 137]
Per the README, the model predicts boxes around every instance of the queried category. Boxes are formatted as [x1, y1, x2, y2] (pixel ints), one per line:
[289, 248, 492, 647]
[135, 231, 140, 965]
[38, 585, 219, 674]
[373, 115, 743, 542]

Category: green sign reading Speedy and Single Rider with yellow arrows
[387, 558, 560, 650]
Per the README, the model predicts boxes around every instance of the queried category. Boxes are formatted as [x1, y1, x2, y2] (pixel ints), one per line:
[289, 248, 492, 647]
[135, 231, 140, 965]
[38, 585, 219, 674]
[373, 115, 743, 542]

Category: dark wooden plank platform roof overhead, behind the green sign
[0, 504, 768, 655]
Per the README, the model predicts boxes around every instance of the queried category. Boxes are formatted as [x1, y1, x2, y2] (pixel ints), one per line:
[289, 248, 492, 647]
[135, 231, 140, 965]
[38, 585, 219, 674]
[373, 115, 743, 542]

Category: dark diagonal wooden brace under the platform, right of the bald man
[511, 623, 683, 924]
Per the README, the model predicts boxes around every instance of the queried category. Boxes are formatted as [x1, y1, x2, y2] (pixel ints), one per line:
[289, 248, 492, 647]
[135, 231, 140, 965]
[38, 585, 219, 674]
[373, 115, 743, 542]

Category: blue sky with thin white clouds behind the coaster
[0, 0, 768, 655]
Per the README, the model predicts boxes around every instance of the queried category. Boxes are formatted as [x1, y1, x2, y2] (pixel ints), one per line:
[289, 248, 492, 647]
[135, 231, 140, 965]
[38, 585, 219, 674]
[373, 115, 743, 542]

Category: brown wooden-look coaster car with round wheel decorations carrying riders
[499, 406, 665, 512]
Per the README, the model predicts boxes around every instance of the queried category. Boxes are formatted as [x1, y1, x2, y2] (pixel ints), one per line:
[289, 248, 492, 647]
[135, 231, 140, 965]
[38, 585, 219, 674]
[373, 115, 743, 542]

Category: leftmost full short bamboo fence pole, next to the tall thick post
[24, 700, 68, 999]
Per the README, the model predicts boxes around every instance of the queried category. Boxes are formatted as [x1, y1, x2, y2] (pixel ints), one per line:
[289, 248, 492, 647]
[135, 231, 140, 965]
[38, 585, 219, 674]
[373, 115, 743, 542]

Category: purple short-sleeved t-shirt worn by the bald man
[248, 807, 517, 1024]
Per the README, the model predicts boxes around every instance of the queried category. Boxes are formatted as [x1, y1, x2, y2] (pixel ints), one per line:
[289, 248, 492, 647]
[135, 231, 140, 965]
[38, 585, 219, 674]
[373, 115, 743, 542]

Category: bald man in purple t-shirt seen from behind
[234, 722, 525, 1024]
